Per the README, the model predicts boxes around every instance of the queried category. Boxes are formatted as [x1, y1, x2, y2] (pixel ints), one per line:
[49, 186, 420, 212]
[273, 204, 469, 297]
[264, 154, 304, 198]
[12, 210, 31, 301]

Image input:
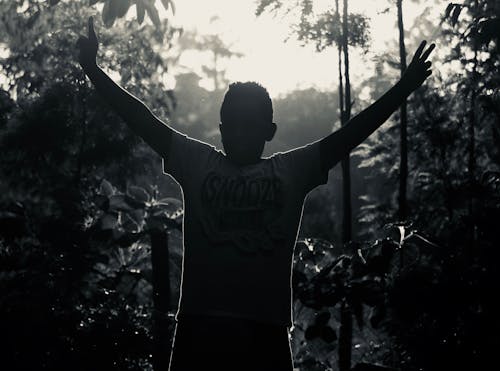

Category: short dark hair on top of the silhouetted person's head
[220, 81, 273, 122]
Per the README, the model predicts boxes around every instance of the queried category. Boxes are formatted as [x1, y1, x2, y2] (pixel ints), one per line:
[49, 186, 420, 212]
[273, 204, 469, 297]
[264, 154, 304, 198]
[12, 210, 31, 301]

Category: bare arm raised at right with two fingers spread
[320, 41, 435, 169]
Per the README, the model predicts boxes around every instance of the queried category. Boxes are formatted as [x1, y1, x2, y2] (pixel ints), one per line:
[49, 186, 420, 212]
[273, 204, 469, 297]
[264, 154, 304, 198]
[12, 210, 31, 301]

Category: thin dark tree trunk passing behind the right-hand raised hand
[397, 0, 408, 224]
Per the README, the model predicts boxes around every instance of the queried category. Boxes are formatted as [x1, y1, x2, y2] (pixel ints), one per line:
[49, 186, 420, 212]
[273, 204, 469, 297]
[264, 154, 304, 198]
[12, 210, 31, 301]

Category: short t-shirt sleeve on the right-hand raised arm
[280, 141, 328, 194]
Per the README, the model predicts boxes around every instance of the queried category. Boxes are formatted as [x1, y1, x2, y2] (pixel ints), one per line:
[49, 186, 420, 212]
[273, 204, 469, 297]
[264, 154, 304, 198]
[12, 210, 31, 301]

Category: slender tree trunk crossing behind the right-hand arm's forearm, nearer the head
[341, 0, 352, 245]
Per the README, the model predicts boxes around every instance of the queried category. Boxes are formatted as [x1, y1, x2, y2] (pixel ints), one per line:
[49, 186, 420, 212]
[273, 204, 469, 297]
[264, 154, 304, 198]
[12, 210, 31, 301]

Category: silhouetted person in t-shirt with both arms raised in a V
[78, 18, 434, 371]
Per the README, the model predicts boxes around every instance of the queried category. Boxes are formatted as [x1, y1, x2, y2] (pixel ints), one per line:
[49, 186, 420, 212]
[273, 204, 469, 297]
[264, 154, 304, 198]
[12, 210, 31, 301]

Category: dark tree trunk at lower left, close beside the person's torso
[151, 231, 171, 371]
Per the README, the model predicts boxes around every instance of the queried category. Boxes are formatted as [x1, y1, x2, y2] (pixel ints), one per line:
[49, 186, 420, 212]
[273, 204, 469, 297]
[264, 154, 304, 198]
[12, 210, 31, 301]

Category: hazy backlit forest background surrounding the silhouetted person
[0, 0, 500, 371]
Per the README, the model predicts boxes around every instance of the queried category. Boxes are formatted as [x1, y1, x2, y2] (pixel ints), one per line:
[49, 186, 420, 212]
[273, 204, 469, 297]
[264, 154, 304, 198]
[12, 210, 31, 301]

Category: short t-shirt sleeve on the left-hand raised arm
[162, 131, 216, 187]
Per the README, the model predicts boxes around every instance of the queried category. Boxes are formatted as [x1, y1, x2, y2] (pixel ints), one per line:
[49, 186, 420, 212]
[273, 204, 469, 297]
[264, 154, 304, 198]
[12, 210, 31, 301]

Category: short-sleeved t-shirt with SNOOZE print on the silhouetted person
[163, 131, 328, 326]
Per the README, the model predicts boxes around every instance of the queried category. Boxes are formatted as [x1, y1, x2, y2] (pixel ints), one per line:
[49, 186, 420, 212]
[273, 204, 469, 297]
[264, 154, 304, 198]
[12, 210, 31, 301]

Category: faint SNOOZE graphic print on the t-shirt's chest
[201, 171, 284, 254]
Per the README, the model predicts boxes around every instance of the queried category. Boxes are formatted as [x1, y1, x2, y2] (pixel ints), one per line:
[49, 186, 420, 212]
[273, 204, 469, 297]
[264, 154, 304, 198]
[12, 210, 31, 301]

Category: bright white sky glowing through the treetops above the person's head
[166, 0, 446, 96]
